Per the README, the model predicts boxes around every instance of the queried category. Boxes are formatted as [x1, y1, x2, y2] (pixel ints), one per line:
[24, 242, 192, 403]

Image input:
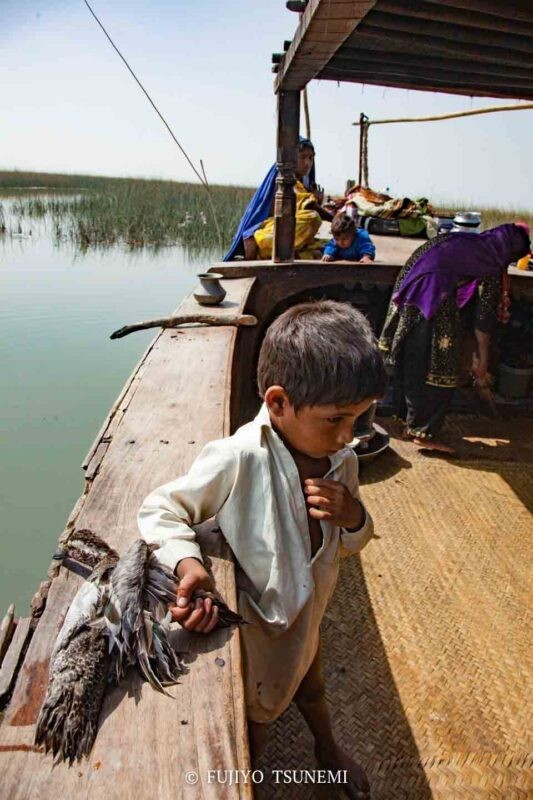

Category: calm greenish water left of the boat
[0, 200, 213, 618]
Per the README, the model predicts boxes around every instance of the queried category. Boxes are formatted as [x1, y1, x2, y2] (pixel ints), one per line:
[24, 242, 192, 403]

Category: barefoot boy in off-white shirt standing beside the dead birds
[139, 300, 386, 798]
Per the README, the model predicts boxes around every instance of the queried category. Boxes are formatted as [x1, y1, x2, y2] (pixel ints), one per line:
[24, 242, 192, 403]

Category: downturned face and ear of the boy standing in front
[265, 386, 376, 458]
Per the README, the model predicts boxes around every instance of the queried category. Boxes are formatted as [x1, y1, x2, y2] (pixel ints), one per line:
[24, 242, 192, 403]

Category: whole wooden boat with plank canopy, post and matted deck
[0, 0, 533, 800]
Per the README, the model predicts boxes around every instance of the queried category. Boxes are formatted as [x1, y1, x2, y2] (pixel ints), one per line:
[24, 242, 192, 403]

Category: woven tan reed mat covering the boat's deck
[255, 417, 533, 800]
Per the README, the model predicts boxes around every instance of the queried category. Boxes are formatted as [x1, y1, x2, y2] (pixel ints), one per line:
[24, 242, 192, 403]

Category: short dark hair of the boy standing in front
[257, 300, 387, 410]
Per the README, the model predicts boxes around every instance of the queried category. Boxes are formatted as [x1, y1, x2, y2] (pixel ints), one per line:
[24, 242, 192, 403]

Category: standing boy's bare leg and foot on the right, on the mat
[294, 645, 370, 800]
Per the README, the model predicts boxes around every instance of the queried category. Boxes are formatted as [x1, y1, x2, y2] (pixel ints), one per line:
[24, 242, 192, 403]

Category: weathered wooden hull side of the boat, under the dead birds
[0, 247, 532, 800]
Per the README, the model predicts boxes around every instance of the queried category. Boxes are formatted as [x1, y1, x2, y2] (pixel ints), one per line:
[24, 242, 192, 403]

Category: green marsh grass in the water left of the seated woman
[0, 172, 254, 254]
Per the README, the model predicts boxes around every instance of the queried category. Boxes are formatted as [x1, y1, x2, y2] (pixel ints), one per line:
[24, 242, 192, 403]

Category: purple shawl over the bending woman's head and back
[393, 223, 531, 319]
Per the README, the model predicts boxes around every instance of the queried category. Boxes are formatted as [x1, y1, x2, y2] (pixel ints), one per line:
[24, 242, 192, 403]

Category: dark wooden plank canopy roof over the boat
[275, 0, 533, 100]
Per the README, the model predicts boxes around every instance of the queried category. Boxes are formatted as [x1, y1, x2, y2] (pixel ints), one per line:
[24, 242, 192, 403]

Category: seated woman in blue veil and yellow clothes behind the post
[224, 137, 332, 261]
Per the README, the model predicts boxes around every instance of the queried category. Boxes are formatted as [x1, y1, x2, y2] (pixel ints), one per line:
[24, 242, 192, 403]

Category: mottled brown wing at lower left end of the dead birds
[35, 622, 109, 764]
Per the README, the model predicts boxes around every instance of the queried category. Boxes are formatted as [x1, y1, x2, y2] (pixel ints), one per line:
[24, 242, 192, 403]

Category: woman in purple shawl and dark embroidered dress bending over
[379, 223, 531, 452]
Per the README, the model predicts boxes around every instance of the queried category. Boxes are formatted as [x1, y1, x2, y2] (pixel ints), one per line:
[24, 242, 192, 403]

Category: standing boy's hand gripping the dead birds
[170, 558, 218, 633]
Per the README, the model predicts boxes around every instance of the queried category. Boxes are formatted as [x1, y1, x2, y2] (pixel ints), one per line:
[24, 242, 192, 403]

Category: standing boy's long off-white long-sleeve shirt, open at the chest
[138, 405, 373, 722]
